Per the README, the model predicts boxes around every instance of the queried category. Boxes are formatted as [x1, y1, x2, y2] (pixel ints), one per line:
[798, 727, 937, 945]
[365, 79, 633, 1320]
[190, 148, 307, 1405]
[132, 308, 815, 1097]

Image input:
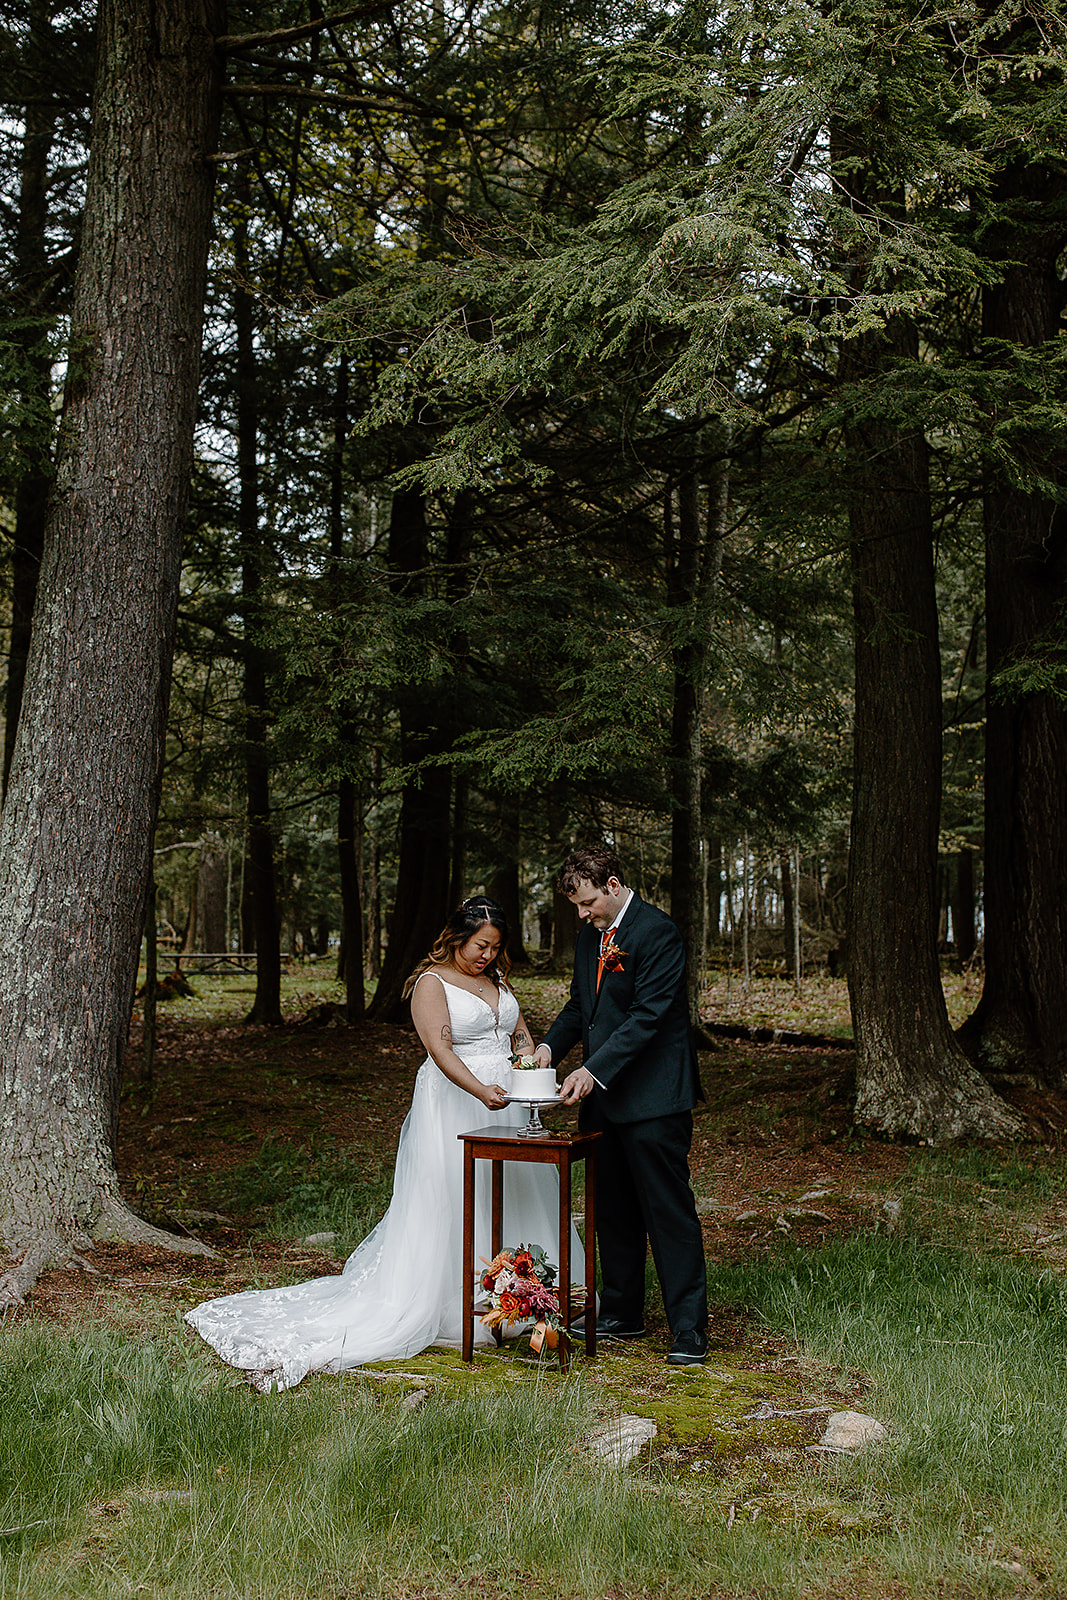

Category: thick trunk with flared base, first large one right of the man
[841, 318, 1019, 1142]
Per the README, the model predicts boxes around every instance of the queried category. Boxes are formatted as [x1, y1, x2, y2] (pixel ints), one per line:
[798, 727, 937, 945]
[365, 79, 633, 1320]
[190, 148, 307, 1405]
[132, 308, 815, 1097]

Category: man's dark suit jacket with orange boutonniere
[545, 894, 701, 1122]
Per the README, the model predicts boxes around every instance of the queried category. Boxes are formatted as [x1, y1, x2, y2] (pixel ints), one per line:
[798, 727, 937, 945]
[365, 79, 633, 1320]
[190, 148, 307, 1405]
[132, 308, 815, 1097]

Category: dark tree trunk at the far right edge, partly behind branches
[961, 166, 1067, 1083]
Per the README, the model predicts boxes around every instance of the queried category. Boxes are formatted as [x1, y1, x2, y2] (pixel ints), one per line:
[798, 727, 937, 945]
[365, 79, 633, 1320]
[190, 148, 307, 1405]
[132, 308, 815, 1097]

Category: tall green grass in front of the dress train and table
[0, 1330, 739, 1597]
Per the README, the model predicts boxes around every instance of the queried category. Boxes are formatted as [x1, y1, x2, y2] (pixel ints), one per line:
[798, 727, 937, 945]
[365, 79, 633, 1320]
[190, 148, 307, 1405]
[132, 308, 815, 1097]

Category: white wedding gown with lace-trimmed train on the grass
[186, 970, 584, 1390]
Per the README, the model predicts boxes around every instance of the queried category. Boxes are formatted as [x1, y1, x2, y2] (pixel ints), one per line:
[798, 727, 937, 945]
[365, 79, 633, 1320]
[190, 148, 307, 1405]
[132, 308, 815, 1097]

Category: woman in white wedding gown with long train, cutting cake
[186, 896, 582, 1390]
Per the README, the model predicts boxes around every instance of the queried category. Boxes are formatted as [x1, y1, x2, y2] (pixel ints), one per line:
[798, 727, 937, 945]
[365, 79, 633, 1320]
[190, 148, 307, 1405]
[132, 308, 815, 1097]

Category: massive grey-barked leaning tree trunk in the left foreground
[0, 0, 224, 1299]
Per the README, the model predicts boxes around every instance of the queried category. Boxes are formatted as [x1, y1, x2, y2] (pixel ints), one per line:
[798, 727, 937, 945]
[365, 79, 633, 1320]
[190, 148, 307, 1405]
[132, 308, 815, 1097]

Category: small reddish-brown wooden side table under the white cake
[459, 1128, 600, 1371]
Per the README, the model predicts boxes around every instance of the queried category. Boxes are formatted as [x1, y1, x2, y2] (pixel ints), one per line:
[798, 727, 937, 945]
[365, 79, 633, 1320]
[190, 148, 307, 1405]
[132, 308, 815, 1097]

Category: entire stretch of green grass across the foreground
[0, 1234, 1067, 1600]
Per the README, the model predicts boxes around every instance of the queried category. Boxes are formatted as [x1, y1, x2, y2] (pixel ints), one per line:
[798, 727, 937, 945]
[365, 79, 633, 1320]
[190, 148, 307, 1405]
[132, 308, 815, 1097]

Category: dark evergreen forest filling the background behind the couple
[0, 0, 1067, 1184]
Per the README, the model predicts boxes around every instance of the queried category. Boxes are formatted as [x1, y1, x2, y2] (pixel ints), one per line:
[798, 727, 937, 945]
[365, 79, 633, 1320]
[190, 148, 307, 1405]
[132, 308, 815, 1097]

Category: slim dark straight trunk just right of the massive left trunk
[234, 173, 282, 1027]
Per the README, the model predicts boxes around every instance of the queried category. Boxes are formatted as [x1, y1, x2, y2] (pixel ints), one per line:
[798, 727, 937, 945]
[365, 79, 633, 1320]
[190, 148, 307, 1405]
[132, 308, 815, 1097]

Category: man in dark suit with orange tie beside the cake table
[536, 846, 707, 1366]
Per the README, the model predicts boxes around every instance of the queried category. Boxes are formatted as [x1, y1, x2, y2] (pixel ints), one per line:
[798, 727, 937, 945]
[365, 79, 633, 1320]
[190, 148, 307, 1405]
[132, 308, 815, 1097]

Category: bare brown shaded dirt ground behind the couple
[16, 979, 1067, 1333]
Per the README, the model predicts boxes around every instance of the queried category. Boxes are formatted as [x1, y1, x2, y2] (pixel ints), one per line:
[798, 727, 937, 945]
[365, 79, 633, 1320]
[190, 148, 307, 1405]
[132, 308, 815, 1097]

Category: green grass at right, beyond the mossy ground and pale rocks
[712, 1235, 1067, 1594]
